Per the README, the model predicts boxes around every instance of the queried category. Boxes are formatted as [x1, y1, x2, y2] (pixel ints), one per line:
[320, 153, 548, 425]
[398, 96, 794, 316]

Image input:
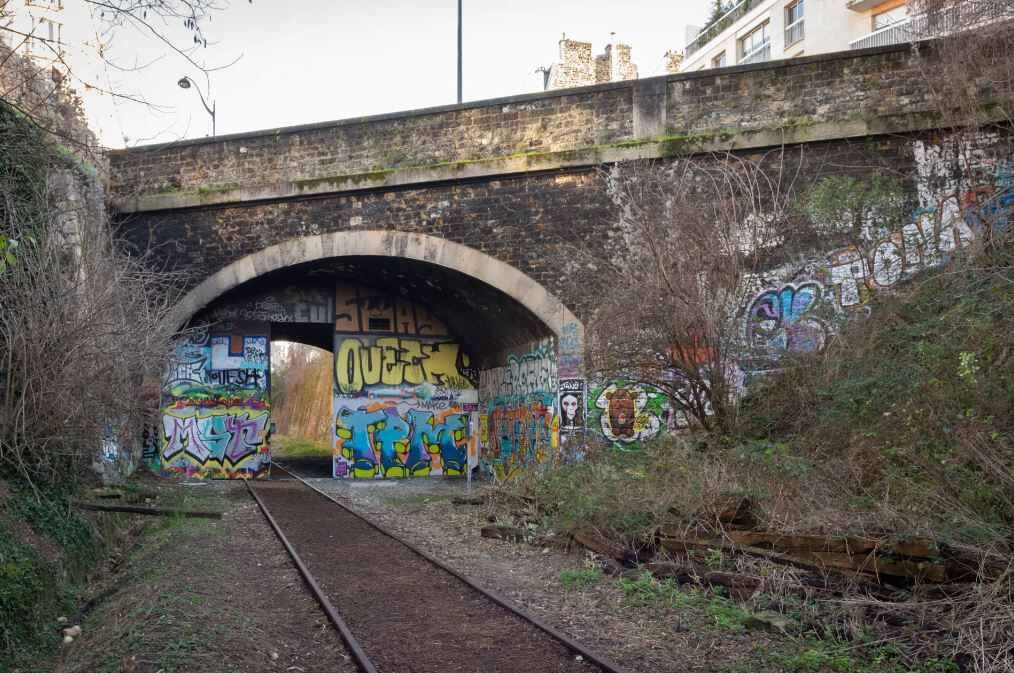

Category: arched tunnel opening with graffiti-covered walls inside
[160, 249, 571, 478]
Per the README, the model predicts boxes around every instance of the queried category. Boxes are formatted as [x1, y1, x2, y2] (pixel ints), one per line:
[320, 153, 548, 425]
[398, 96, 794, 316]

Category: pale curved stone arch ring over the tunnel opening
[176, 230, 584, 344]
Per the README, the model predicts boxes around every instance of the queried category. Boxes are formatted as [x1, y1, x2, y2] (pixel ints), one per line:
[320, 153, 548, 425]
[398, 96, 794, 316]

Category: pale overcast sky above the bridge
[65, 0, 711, 147]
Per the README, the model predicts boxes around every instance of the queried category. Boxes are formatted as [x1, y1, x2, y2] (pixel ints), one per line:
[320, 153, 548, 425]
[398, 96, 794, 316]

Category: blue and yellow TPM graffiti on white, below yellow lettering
[335, 401, 475, 478]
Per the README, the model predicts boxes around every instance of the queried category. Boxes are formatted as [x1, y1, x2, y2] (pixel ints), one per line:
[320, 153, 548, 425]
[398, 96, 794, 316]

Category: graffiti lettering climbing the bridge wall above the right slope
[739, 146, 1014, 370]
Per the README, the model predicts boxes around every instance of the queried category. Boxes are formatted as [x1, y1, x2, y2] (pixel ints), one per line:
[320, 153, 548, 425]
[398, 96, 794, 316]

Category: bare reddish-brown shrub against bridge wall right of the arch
[587, 150, 804, 429]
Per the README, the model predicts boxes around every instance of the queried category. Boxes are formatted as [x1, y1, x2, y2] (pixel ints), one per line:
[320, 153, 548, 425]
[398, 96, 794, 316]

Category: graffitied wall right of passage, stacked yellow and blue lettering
[334, 285, 479, 478]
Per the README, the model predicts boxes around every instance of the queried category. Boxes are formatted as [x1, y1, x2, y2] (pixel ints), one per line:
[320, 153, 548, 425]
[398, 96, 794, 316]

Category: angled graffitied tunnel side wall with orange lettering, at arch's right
[480, 340, 562, 478]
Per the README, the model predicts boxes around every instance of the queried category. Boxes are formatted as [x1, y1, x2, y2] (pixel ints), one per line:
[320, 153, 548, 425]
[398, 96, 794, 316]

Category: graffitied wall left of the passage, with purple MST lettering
[159, 323, 271, 478]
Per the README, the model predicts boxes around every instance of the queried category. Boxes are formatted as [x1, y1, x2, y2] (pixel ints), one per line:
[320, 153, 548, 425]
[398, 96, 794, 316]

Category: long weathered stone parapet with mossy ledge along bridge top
[110, 47, 937, 212]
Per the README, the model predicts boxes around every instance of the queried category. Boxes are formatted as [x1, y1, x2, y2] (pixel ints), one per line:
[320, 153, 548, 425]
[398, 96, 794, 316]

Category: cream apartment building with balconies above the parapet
[679, 0, 920, 72]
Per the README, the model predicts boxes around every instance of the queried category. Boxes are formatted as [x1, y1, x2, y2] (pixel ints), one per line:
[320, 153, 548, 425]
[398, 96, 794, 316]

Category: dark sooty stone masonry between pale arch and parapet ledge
[121, 137, 914, 326]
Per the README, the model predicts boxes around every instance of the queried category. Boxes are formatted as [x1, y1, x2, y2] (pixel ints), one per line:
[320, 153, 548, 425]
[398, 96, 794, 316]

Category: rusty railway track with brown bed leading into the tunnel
[246, 463, 625, 673]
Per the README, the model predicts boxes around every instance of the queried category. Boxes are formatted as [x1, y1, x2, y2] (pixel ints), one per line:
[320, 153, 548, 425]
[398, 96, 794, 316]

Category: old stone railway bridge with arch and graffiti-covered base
[110, 43, 1005, 477]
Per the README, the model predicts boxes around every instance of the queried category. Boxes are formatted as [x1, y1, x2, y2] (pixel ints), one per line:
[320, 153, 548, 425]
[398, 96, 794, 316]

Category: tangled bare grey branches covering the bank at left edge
[0, 95, 176, 483]
